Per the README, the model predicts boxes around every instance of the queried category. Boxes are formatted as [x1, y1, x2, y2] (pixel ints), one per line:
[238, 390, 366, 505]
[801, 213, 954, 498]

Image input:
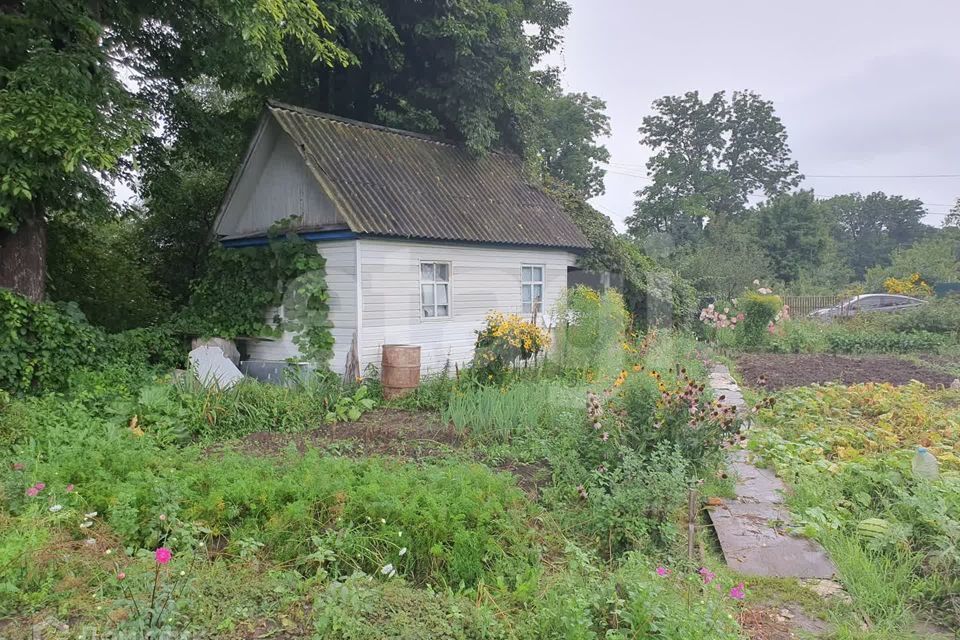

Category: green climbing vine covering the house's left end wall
[177, 227, 333, 365]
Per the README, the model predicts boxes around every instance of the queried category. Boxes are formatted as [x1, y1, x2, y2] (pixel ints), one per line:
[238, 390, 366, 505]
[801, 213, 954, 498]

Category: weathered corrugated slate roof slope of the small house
[268, 102, 590, 249]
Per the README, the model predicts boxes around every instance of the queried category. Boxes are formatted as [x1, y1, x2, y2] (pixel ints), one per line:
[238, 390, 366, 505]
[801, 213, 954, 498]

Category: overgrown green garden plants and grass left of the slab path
[0, 308, 752, 640]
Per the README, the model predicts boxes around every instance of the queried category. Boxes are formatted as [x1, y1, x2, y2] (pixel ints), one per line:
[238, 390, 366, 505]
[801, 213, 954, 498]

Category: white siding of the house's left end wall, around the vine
[247, 240, 357, 374]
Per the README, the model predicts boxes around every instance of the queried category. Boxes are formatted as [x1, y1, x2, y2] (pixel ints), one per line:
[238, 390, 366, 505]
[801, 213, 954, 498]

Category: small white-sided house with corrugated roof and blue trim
[215, 102, 590, 373]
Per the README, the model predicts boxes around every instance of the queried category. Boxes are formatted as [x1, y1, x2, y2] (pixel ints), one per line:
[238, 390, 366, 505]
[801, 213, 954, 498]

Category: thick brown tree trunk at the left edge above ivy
[0, 216, 47, 302]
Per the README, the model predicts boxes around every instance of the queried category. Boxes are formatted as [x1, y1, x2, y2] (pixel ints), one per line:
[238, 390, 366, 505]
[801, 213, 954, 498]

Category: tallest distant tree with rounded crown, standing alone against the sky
[627, 91, 802, 244]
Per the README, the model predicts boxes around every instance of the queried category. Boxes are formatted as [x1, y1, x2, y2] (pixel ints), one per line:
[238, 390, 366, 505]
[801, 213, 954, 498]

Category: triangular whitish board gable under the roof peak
[216, 122, 343, 237]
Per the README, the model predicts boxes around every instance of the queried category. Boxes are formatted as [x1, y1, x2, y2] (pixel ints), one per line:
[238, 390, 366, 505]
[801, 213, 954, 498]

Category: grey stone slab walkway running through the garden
[709, 365, 836, 579]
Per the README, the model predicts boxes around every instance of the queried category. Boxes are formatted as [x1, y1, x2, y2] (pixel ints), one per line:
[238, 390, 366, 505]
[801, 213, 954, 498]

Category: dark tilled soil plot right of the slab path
[737, 353, 953, 389]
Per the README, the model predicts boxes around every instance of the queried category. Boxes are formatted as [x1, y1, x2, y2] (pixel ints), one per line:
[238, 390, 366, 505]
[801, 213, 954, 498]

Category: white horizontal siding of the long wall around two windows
[358, 239, 576, 373]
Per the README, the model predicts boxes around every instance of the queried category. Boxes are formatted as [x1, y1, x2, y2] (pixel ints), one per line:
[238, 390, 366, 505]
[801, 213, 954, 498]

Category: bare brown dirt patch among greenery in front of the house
[208, 409, 550, 499]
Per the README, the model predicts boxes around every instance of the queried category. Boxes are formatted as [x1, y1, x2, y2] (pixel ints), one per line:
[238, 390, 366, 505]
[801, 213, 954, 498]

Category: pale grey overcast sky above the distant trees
[548, 0, 960, 228]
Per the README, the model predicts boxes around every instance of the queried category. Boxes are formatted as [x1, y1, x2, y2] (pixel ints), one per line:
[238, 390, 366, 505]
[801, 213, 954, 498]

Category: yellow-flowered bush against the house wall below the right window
[473, 311, 550, 381]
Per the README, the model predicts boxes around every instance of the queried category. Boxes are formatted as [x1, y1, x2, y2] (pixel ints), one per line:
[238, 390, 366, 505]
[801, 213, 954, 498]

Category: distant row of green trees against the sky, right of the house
[627, 92, 960, 299]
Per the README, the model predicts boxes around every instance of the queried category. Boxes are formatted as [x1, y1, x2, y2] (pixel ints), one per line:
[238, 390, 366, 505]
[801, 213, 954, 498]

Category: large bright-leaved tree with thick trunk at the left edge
[0, 0, 355, 299]
